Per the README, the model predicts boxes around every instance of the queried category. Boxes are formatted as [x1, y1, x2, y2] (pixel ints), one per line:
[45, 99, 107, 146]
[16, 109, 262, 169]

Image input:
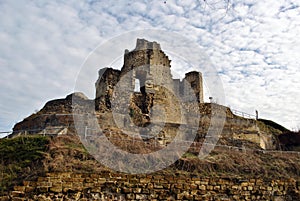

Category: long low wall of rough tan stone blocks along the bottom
[6, 172, 300, 201]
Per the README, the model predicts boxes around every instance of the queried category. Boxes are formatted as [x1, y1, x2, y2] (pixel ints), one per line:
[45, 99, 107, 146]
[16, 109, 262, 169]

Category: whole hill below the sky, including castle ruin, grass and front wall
[0, 39, 300, 201]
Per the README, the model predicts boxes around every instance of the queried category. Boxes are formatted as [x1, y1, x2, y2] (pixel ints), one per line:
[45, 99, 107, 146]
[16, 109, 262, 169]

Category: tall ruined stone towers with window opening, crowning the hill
[96, 39, 203, 125]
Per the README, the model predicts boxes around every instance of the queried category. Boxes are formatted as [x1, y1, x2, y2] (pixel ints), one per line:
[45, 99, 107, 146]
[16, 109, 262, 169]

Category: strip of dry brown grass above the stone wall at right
[171, 149, 300, 179]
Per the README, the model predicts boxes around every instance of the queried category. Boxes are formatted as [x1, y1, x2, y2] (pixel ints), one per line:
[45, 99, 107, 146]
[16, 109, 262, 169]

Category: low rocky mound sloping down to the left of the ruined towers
[10, 92, 93, 137]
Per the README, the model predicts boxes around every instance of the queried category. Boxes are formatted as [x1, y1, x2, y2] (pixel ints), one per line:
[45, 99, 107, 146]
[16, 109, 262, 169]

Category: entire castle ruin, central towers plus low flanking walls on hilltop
[11, 39, 281, 149]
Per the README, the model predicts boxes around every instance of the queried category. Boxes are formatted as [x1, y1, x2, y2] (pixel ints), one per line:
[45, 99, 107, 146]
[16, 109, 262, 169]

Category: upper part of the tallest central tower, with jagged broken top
[121, 39, 173, 96]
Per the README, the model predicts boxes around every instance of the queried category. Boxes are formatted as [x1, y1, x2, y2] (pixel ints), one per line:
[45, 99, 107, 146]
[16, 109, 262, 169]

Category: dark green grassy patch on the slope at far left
[0, 136, 49, 193]
